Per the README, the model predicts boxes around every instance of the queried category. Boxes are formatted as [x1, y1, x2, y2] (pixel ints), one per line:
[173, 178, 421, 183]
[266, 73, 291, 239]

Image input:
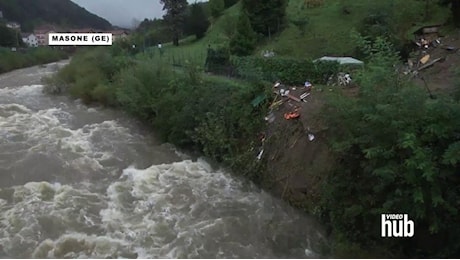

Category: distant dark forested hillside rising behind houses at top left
[0, 0, 111, 31]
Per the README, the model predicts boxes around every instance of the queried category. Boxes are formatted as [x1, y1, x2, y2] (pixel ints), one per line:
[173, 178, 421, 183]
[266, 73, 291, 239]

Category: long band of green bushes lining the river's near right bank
[47, 48, 270, 179]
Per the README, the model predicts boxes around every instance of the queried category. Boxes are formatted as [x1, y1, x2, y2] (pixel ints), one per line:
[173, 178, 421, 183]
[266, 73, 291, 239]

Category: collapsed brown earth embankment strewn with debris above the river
[261, 88, 334, 212]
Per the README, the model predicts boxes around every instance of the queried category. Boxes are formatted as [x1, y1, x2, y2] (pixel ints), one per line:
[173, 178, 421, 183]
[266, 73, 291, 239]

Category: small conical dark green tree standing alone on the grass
[230, 11, 257, 56]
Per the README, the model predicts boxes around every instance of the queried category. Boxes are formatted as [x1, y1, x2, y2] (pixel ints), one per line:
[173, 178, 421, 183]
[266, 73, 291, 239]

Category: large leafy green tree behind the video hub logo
[323, 34, 460, 257]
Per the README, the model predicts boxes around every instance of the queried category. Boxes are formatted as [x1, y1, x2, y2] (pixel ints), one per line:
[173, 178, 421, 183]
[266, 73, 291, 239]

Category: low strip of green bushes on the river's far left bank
[0, 47, 68, 73]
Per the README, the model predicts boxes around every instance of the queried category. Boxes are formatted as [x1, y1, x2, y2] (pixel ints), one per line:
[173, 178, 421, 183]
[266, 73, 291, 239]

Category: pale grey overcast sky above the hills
[72, 0, 199, 28]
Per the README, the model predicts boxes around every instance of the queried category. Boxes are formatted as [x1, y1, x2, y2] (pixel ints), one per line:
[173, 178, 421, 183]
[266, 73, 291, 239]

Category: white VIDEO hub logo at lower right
[382, 214, 415, 237]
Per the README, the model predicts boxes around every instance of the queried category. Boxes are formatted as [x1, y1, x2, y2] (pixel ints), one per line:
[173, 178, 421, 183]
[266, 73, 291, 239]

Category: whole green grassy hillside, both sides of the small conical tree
[141, 0, 450, 66]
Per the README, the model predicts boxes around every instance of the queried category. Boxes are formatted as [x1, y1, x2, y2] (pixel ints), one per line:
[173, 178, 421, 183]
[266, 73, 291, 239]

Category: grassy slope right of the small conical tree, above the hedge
[260, 0, 450, 58]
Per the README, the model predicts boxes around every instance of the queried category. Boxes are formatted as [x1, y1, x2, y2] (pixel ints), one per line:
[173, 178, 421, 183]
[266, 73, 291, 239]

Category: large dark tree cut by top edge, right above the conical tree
[242, 0, 287, 36]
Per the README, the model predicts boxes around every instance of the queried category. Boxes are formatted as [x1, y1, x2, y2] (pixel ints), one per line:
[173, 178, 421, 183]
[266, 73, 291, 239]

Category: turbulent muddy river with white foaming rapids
[0, 61, 324, 258]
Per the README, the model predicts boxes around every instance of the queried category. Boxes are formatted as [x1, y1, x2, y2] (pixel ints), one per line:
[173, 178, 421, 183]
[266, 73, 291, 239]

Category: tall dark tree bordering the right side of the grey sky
[160, 0, 188, 46]
